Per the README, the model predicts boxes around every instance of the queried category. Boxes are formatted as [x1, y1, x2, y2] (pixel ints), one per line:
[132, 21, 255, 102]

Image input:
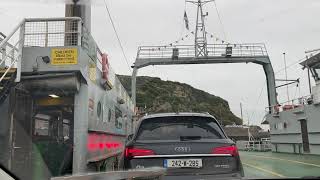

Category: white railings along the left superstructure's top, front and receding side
[0, 17, 133, 109]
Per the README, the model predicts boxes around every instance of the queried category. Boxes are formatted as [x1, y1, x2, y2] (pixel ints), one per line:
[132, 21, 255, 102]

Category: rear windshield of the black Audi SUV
[136, 116, 225, 141]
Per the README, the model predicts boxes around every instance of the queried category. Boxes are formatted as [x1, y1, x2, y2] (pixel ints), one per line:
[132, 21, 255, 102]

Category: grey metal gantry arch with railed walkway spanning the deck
[131, 44, 277, 112]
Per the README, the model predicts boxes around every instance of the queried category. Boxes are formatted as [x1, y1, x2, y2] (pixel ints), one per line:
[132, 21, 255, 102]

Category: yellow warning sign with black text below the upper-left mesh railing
[51, 48, 78, 65]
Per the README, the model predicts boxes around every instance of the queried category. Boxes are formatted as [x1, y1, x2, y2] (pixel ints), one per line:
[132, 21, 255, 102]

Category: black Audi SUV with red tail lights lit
[123, 113, 243, 180]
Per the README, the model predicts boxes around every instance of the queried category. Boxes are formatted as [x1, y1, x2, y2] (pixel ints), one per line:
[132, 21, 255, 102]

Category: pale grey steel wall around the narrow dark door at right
[266, 105, 320, 155]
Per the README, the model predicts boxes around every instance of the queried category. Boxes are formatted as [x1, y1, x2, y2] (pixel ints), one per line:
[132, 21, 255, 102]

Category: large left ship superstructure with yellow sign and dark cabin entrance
[0, 5, 134, 179]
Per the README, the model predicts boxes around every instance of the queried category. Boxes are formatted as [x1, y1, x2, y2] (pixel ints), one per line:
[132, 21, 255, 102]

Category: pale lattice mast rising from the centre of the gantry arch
[186, 0, 214, 57]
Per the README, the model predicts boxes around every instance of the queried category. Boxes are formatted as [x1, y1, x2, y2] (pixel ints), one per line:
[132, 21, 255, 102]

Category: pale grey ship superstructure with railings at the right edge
[264, 53, 320, 155]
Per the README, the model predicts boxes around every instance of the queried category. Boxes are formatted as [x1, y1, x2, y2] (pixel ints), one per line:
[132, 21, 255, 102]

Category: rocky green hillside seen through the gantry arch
[118, 75, 242, 125]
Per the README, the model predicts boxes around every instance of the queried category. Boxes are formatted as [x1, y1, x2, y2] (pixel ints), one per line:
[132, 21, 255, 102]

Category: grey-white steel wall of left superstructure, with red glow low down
[22, 46, 134, 173]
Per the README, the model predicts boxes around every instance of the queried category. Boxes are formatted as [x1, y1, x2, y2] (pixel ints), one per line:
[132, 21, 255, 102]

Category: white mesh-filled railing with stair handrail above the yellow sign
[0, 17, 82, 82]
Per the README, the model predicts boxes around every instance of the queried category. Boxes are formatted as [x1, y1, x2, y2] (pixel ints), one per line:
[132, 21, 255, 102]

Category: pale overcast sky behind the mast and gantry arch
[0, 0, 320, 127]
